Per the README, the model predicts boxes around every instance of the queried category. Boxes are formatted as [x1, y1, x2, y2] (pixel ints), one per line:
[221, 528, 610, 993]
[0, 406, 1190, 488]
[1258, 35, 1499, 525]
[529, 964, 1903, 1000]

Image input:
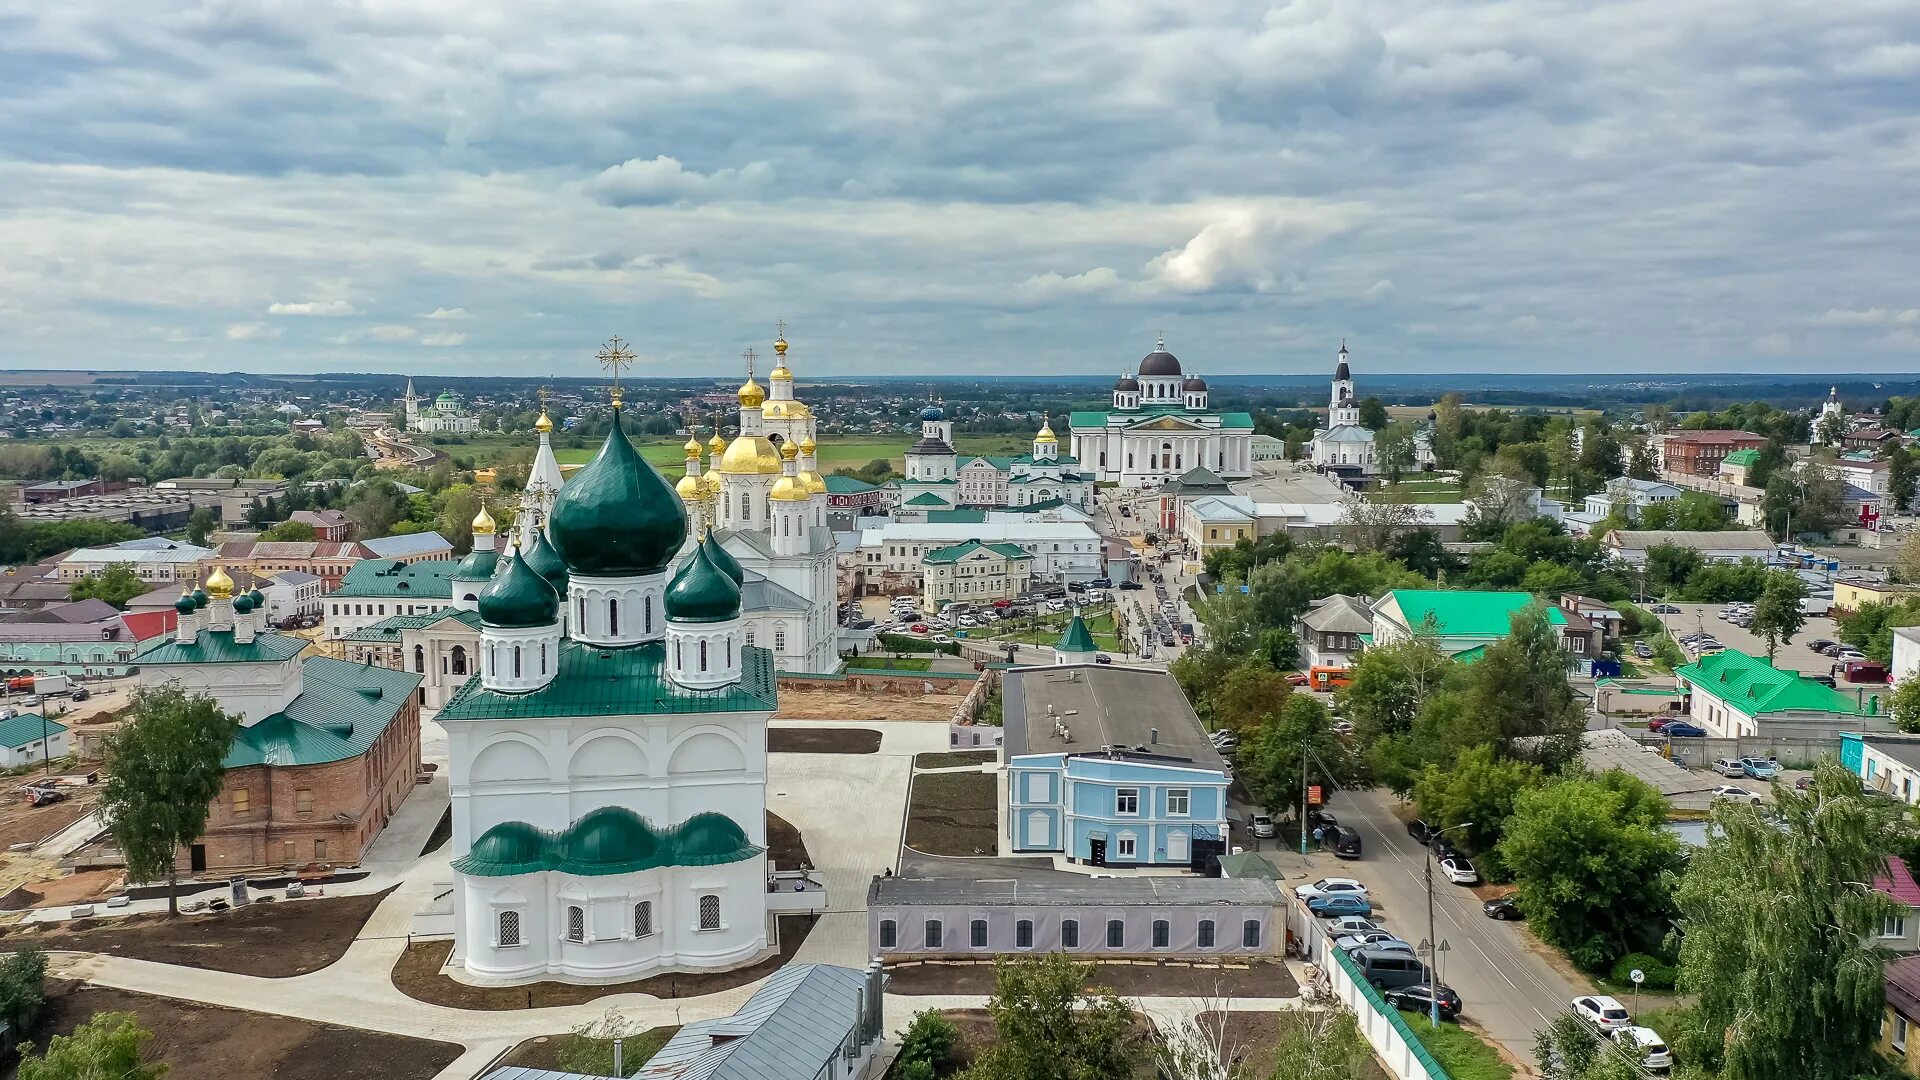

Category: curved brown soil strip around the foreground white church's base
[394, 915, 818, 1011]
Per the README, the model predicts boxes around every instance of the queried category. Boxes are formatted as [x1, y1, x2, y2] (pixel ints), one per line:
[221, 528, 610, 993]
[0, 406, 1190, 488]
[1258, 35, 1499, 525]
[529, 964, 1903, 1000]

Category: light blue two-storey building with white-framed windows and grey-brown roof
[1000, 663, 1227, 871]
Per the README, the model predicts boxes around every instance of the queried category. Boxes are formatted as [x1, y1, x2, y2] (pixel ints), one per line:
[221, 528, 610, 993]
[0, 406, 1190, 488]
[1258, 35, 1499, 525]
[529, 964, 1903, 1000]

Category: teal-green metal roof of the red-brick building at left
[221, 657, 424, 769]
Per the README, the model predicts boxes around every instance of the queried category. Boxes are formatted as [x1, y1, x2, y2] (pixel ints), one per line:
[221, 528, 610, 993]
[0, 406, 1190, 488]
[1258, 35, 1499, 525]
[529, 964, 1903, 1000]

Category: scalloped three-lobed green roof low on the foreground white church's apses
[453, 807, 766, 878]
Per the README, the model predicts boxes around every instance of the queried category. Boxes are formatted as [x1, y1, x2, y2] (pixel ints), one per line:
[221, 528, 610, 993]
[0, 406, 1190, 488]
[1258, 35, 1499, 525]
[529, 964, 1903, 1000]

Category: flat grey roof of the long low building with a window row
[866, 871, 1281, 907]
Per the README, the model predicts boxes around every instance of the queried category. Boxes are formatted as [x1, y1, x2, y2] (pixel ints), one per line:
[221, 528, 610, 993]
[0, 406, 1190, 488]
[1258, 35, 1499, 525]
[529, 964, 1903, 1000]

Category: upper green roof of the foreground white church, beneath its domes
[440, 640, 776, 723]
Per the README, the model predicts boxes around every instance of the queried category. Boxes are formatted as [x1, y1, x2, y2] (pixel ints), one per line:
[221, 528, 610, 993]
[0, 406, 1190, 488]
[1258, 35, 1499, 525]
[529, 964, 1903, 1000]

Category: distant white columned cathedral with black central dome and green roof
[1069, 338, 1254, 488]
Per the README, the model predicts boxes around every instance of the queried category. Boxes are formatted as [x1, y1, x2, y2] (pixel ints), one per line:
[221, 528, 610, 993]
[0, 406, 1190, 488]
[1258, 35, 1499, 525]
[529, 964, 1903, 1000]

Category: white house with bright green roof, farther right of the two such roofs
[1674, 650, 1889, 738]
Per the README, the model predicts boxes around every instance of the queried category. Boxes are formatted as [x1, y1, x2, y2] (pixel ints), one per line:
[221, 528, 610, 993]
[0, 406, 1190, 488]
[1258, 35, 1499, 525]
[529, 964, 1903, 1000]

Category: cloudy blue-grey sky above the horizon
[0, 0, 1920, 377]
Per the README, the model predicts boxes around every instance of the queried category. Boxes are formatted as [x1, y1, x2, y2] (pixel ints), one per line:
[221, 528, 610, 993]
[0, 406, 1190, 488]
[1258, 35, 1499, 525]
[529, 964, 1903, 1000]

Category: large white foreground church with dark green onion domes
[438, 380, 787, 984]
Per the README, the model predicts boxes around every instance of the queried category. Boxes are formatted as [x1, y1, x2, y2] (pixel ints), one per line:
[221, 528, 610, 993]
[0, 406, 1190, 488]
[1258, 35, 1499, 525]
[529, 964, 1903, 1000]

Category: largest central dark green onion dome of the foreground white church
[549, 411, 687, 577]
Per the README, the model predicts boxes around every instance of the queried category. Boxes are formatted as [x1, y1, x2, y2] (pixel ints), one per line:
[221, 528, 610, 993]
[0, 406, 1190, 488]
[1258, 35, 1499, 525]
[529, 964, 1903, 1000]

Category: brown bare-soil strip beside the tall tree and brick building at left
[0, 890, 394, 978]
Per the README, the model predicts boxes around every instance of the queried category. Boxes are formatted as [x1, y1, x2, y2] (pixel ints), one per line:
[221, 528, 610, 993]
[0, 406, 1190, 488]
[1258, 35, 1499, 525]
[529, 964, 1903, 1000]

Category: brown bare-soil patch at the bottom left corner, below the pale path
[6, 980, 461, 1080]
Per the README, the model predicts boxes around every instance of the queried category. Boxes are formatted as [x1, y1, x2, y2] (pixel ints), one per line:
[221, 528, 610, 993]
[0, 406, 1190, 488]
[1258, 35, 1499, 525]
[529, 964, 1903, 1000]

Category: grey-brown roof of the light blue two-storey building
[1002, 663, 1227, 769]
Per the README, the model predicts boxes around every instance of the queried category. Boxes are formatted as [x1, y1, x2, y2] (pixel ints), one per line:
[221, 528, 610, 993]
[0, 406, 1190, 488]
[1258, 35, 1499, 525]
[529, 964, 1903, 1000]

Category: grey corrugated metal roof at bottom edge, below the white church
[636, 965, 866, 1080]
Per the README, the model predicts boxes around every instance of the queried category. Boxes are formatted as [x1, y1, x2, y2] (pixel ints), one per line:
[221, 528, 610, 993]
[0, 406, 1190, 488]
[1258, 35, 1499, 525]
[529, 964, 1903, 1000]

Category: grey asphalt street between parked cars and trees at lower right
[1305, 790, 1592, 1063]
